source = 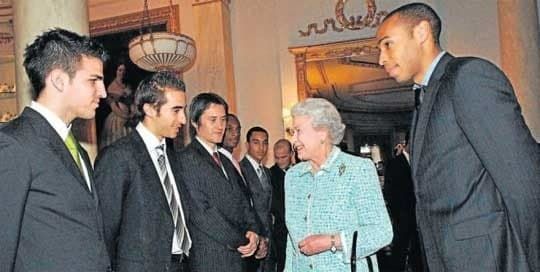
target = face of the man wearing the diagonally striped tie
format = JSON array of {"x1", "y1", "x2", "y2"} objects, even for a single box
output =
[{"x1": 144, "y1": 87, "x2": 186, "y2": 140}]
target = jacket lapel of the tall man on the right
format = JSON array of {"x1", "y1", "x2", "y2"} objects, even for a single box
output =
[{"x1": 411, "y1": 53, "x2": 454, "y2": 177}]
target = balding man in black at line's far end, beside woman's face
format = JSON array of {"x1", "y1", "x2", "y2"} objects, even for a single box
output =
[{"x1": 270, "y1": 139, "x2": 294, "y2": 272}]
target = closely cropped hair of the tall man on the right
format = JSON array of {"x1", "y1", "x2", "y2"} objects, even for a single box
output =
[{"x1": 383, "y1": 3, "x2": 442, "y2": 45}]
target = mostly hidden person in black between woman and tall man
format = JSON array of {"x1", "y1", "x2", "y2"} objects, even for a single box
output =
[{"x1": 384, "y1": 139, "x2": 422, "y2": 271}]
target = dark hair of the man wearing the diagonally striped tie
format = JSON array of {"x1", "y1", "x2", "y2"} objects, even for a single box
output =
[{"x1": 132, "y1": 71, "x2": 186, "y2": 124}]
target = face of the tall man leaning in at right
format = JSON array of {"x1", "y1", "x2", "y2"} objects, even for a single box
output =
[{"x1": 377, "y1": 15, "x2": 423, "y2": 83}]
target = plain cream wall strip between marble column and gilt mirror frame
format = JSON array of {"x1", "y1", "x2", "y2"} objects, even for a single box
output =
[{"x1": 231, "y1": 0, "x2": 283, "y2": 163}]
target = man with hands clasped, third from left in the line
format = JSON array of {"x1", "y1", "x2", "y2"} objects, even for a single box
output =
[{"x1": 179, "y1": 93, "x2": 260, "y2": 272}]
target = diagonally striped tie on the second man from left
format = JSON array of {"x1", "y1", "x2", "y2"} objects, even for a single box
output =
[{"x1": 156, "y1": 145, "x2": 191, "y2": 255}]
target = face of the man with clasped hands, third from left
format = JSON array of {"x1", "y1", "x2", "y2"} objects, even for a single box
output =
[{"x1": 192, "y1": 103, "x2": 227, "y2": 148}]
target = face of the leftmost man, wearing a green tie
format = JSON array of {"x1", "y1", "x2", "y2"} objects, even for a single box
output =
[{"x1": 61, "y1": 55, "x2": 107, "y2": 122}]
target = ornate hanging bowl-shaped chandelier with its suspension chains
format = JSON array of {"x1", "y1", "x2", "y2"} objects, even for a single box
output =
[{"x1": 129, "y1": 0, "x2": 197, "y2": 72}]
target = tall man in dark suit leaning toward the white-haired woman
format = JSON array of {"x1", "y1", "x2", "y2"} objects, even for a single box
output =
[{"x1": 377, "y1": 3, "x2": 540, "y2": 271}]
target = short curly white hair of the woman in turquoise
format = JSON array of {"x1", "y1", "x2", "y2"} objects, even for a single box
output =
[{"x1": 291, "y1": 98, "x2": 345, "y2": 145}]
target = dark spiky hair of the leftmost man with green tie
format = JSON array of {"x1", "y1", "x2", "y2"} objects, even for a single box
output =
[{"x1": 23, "y1": 28, "x2": 108, "y2": 99}]
